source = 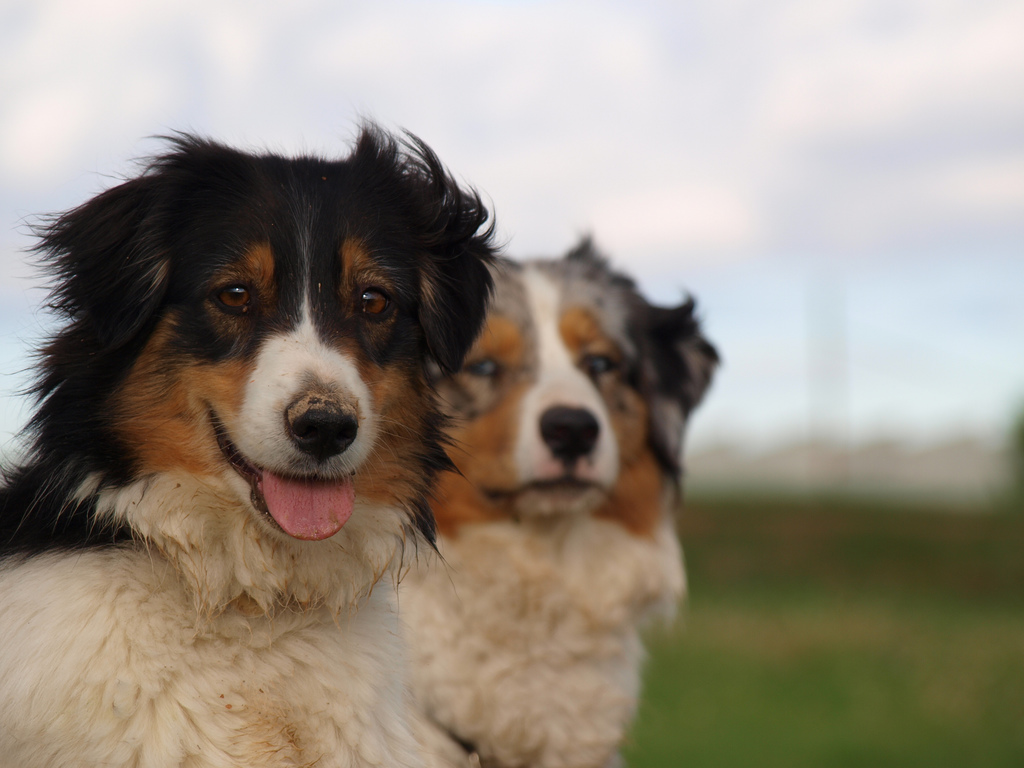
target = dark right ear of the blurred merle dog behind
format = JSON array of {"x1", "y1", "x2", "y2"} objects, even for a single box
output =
[{"x1": 634, "y1": 297, "x2": 719, "y2": 472}]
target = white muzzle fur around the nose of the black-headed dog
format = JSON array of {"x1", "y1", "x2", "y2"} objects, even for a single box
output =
[{"x1": 230, "y1": 308, "x2": 378, "y2": 475}]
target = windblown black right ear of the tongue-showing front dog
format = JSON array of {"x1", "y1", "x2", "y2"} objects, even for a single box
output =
[{"x1": 393, "y1": 134, "x2": 497, "y2": 374}]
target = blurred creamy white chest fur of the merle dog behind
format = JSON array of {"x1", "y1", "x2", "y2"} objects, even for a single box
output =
[{"x1": 402, "y1": 517, "x2": 685, "y2": 768}]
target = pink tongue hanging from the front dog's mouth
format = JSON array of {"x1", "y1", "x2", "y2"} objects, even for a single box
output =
[{"x1": 260, "y1": 472, "x2": 355, "y2": 542}]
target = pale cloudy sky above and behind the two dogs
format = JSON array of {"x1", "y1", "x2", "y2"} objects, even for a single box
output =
[{"x1": 0, "y1": 0, "x2": 1024, "y2": 450}]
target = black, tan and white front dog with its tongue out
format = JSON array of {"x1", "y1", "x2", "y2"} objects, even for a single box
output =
[{"x1": 0, "y1": 127, "x2": 493, "y2": 768}]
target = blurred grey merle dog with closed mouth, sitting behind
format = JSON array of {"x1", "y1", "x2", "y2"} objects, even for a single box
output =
[{"x1": 402, "y1": 241, "x2": 718, "y2": 768}]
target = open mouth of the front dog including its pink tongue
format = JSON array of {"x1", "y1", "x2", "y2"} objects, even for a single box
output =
[{"x1": 210, "y1": 410, "x2": 355, "y2": 542}]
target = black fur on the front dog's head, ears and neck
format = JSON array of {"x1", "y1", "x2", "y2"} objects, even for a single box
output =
[{"x1": 0, "y1": 126, "x2": 494, "y2": 556}]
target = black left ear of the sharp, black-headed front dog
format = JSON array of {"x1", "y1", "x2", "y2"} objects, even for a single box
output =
[{"x1": 36, "y1": 175, "x2": 170, "y2": 348}]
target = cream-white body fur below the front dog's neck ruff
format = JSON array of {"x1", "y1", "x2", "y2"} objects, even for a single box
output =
[{"x1": 0, "y1": 550, "x2": 420, "y2": 768}]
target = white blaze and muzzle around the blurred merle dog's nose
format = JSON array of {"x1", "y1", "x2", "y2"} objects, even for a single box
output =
[{"x1": 515, "y1": 268, "x2": 618, "y2": 488}]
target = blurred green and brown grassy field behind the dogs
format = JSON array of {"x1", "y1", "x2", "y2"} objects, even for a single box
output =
[{"x1": 626, "y1": 500, "x2": 1024, "y2": 768}]
